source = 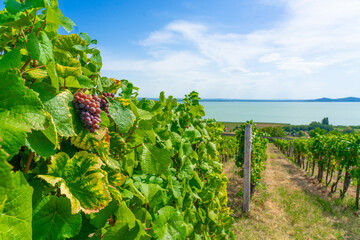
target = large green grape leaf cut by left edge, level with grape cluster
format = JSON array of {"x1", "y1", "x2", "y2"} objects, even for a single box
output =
[{"x1": 0, "y1": 73, "x2": 46, "y2": 156}]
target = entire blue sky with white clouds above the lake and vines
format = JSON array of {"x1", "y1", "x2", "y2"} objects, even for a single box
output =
[{"x1": 2, "y1": 0, "x2": 360, "y2": 99}]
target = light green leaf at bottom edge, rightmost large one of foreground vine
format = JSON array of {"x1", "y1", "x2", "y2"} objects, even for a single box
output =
[{"x1": 152, "y1": 206, "x2": 186, "y2": 240}]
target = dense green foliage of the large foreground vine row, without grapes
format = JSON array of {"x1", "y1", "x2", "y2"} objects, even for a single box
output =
[{"x1": 0, "y1": 0, "x2": 234, "y2": 240}]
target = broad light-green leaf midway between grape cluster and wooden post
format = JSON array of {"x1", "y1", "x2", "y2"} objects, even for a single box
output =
[{"x1": 140, "y1": 144, "x2": 171, "y2": 174}]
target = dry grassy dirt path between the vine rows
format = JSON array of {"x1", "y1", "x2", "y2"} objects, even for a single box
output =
[{"x1": 224, "y1": 144, "x2": 360, "y2": 239}]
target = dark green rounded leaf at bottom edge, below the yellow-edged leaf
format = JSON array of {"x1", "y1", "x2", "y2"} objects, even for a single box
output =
[{"x1": 33, "y1": 196, "x2": 81, "y2": 240}]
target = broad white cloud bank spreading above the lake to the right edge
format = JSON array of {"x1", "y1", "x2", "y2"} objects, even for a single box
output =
[{"x1": 104, "y1": 0, "x2": 360, "y2": 98}]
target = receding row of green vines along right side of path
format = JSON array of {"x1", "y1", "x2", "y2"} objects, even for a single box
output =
[{"x1": 274, "y1": 134, "x2": 360, "y2": 208}]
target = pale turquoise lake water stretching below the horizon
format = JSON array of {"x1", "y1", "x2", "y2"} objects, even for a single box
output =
[{"x1": 201, "y1": 102, "x2": 360, "y2": 126}]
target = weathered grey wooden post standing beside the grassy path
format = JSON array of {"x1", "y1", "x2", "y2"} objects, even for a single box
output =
[{"x1": 242, "y1": 125, "x2": 252, "y2": 212}]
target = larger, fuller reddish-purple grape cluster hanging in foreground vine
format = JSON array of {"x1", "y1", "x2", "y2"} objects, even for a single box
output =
[{"x1": 74, "y1": 92, "x2": 101, "y2": 133}]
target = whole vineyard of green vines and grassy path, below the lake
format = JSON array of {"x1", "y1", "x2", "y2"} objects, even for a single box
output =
[{"x1": 0, "y1": 0, "x2": 360, "y2": 240}]
